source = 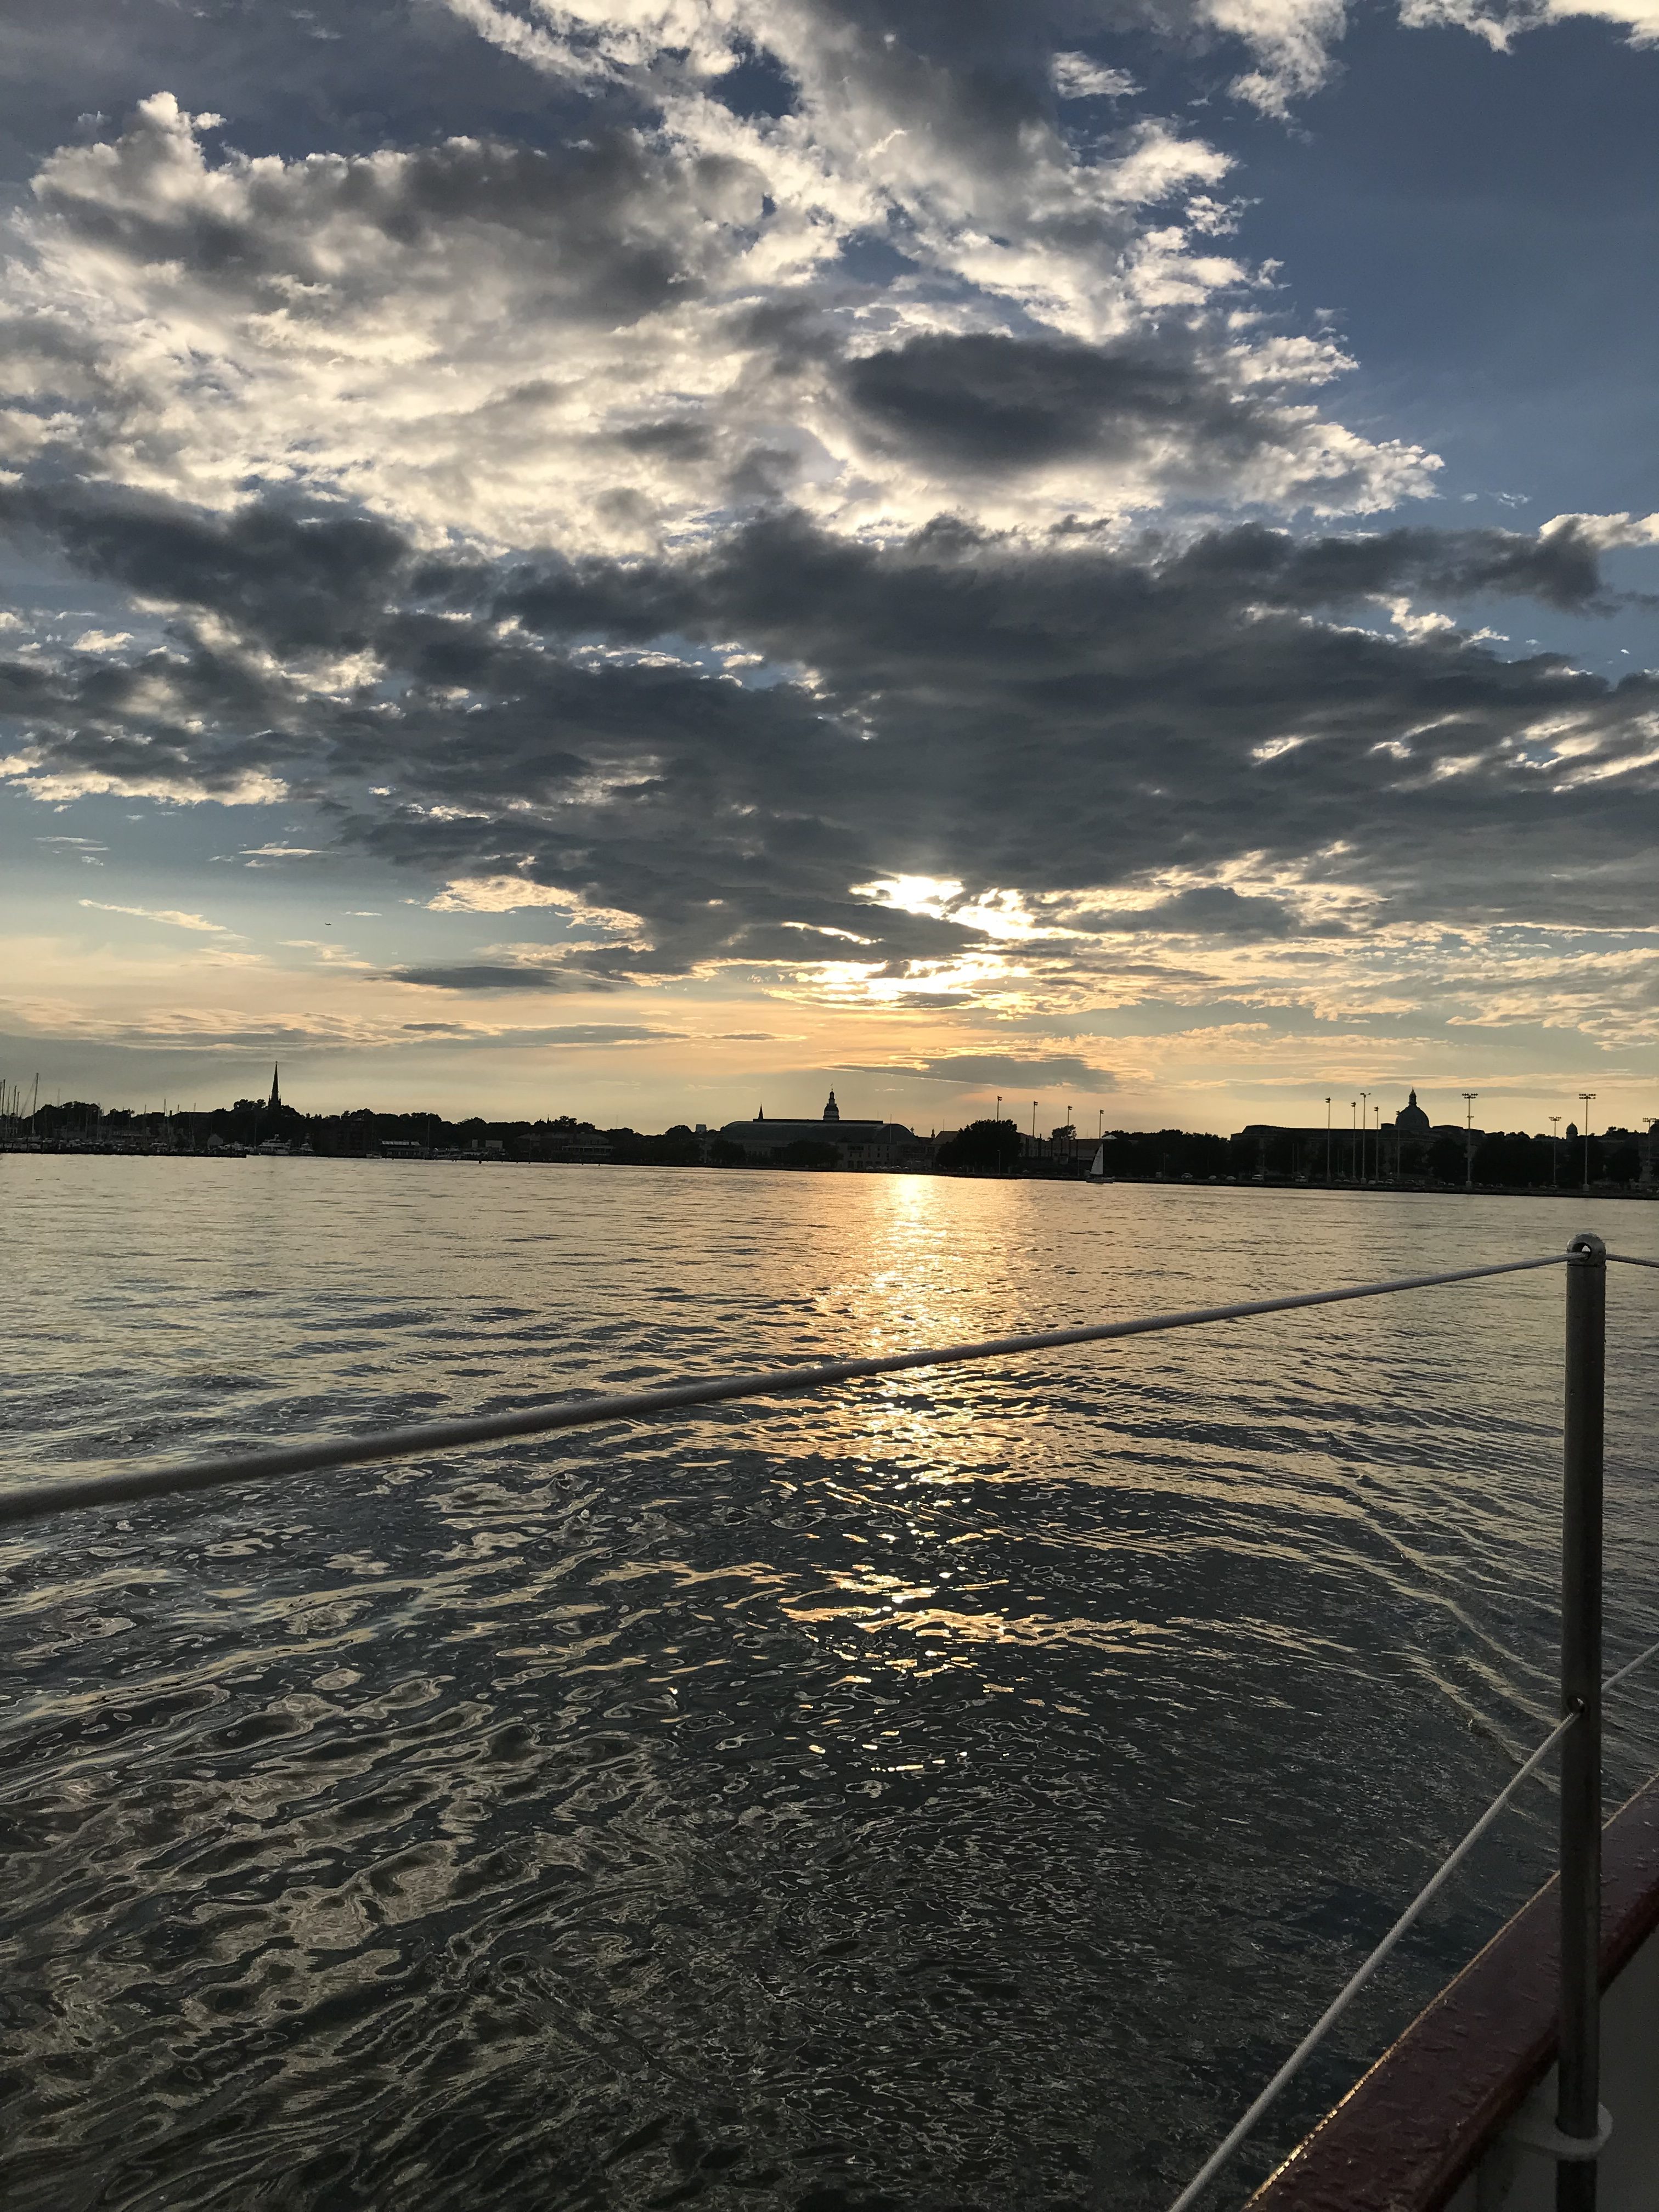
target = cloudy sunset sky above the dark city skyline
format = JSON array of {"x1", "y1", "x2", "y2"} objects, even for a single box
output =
[{"x1": 0, "y1": 0, "x2": 1659, "y2": 1132}]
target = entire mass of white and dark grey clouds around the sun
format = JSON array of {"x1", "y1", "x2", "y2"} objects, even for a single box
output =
[{"x1": 0, "y1": 0, "x2": 1659, "y2": 1084}]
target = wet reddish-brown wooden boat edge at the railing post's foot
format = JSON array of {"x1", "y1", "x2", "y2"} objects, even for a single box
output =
[{"x1": 1248, "y1": 1774, "x2": 1659, "y2": 2212}]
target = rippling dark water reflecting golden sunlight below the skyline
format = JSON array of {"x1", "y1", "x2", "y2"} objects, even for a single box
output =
[{"x1": 0, "y1": 1157, "x2": 1659, "y2": 2212}]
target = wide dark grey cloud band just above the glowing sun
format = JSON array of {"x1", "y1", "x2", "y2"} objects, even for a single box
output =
[{"x1": 0, "y1": 498, "x2": 1659, "y2": 991}]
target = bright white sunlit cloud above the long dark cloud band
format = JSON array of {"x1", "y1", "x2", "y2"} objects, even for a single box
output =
[{"x1": 0, "y1": 45, "x2": 1434, "y2": 550}]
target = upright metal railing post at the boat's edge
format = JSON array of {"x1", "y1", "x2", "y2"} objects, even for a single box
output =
[{"x1": 1555, "y1": 1234, "x2": 1608, "y2": 2212}]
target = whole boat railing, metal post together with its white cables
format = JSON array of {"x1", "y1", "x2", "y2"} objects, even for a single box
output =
[{"x1": 0, "y1": 1232, "x2": 1659, "y2": 2212}]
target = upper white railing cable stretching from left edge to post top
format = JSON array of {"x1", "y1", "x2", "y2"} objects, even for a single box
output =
[{"x1": 0, "y1": 1252, "x2": 1566, "y2": 1526}]
